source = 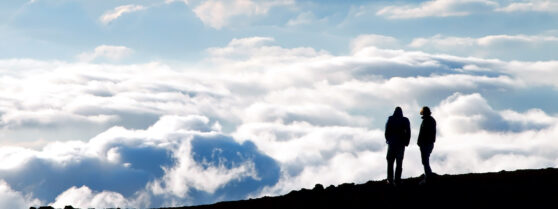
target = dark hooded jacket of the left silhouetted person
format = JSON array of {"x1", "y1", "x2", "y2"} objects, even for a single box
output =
[{"x1": 385, "y1": 108, "x2": 411, "y2": 146}]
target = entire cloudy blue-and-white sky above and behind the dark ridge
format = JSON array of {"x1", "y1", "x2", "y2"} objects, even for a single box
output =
[{"x1": 0, "y1": 0, "x2": 558, "y2": 208}]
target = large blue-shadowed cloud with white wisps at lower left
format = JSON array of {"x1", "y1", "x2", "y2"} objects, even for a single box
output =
[{"x1": 0, "y1": 115, "x2": 279, "y2": 208}]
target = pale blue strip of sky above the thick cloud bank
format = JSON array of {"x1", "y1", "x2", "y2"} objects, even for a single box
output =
[{"x1": 4, "y1": 0, "x2": 558, "y2": 62}]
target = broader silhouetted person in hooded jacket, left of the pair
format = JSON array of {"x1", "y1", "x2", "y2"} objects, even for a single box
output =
[{"x1": 385, "y1": 107, "x2": 411, "y2": 185}]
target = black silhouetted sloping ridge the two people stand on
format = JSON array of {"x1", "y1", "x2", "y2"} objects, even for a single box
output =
[{"x1": 34, "y1": 168, "x2": 558, "y2": 209}]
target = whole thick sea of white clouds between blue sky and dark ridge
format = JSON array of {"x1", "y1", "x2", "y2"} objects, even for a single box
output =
[{"x1": 0, "y1": 34, "x2": 558, "y2": 207}]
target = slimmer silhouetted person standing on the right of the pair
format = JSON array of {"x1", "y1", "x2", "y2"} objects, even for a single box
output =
[{"x1": 417, "y1": 106, "x2": 436, "y2": 183}]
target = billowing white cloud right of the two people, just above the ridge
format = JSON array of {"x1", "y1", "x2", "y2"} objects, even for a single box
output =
[{"x1": 433, "y1": 94, "x2": 558, "y2": 173}]
